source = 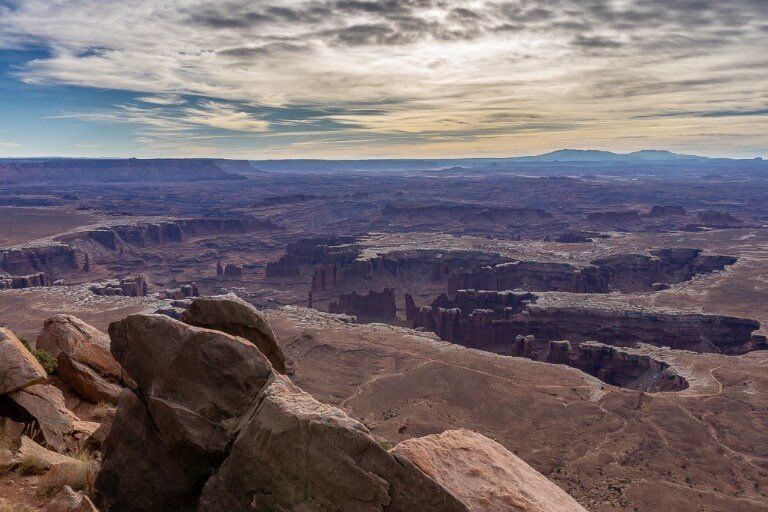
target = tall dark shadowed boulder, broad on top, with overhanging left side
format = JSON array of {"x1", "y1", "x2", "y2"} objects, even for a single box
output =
[{"x1": 96, "y1": 315, "x2": 273, "y2": 512}]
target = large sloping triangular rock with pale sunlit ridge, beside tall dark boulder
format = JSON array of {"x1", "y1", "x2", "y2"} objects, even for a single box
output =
[{"x1": 198, "y1": 376, "x2": 466, "y2": 512}]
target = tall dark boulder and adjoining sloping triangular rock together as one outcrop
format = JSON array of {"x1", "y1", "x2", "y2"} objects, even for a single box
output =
[{"x1": 95, "y1": 315, "x2": 467, "y2": 512}]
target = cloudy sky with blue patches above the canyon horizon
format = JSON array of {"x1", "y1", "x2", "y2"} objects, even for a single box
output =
[{"x1": 0, "y1": 0, "x2": 768, "y2": 159}]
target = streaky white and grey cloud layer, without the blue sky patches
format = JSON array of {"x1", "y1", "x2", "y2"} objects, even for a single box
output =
[{"x1": 0, "y1": 0, "x2": 768, "y2": 156}]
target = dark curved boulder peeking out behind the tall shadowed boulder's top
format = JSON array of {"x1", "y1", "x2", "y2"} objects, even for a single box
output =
[{"x1": 181, "y1": 294, "x2": 285, "y2": 374}]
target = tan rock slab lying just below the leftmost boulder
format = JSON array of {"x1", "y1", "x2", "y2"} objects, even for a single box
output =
[{"x1": 8, "y1": 384, "x2": 80, "y2": 451}]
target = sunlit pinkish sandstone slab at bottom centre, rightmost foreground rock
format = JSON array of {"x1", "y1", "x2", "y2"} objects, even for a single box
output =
[{"x1": 392, "y1": 430, "x2": 586, "y2": 512}]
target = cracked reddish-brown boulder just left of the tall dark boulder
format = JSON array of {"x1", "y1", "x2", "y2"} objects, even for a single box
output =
[{"x1": 37, "y1": 315, "x2": 127, "y2": 403}]
